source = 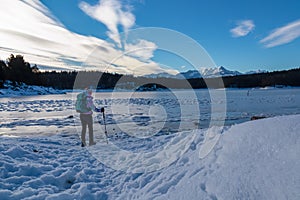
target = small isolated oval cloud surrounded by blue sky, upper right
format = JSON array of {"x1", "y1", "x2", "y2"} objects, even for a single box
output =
[{"x1": 230, "y1": 20, "x2": 255, "y2": 37}]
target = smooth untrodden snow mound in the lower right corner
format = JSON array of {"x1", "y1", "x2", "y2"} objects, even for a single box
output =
[{"x1": 207, "y1": 116, "x2": 300, "y2": 199}]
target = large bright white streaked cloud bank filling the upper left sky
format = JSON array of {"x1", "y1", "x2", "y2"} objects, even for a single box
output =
[{"x1": 0, "y1": 0, "x2": 169, "y2": 75}]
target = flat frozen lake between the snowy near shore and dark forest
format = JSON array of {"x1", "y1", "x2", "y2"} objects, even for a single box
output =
[{"x1": 0, "y1": 88, "x2": 300, "y2": 137}]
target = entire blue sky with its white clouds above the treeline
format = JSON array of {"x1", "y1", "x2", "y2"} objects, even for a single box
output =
[{"x1": 0, "y1": 0, "x2": 300, "y2": 74}]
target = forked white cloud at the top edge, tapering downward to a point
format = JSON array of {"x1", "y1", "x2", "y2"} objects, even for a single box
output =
[{"x1": 79, "y1": 0, "x2": 135, "y2": 47}]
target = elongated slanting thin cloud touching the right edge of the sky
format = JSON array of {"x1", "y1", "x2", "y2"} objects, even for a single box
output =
[{"x1": 260, "y1": 20, "x2": 300, "y2": 48}]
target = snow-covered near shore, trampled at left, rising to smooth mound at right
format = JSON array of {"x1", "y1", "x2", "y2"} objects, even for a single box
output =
[{"x1": 0, "y1": 115, "x2": 300, "y2": 200}]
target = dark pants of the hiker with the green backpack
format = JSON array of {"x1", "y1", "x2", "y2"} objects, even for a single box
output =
[{"x1": 80, "y1": 114, "x2": 94, "y2": 146}]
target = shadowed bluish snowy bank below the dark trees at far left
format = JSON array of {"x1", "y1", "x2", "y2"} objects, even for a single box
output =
[{"x1": 0, "y1": 81, "x2": 65, "y2": 97}]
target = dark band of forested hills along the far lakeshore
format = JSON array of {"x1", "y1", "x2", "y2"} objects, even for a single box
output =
[{"x1": 0, "y1": 55, "x2": 300, "y2": 89}]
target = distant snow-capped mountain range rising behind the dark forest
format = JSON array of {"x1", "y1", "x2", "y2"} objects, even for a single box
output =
[{"x1": 144, "y1": 66, "x2": 267, "y2": 79}]
